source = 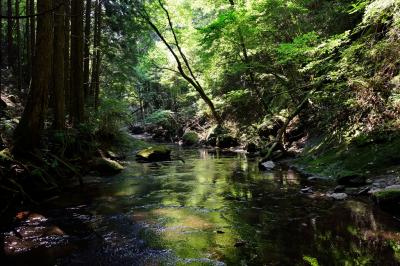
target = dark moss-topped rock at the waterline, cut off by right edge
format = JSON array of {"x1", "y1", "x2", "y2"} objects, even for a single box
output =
[{"x1": 372, "y1": 188, "x2": 400, "y2": 213}]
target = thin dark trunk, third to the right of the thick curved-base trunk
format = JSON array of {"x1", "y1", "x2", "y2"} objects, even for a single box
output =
[{"x1": 83, "y1": 0, "x2": 92, "y2": 101}]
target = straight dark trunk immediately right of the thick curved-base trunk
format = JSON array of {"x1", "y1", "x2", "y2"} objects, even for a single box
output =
[{"x1": 53, "y1": 0, "x2": 65, "y2": 130}]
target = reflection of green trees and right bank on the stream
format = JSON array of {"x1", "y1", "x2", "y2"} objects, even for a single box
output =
[{"x1": 52, "y1": 150, "x2": 395, "y2": 265}]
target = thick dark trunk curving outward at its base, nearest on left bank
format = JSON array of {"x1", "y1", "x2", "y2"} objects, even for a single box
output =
[{"x1": 14, "y1": 0, "x2": 53, "y2": 153}]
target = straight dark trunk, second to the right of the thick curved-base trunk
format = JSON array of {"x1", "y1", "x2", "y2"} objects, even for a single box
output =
[{"x1": 71, "y1": 0, "x2": 84, "y2": 126}]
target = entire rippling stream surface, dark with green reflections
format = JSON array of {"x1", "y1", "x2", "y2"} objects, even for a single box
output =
[{"x1": 0, "y1": 147, "x2": 400, "y2": 266}]
